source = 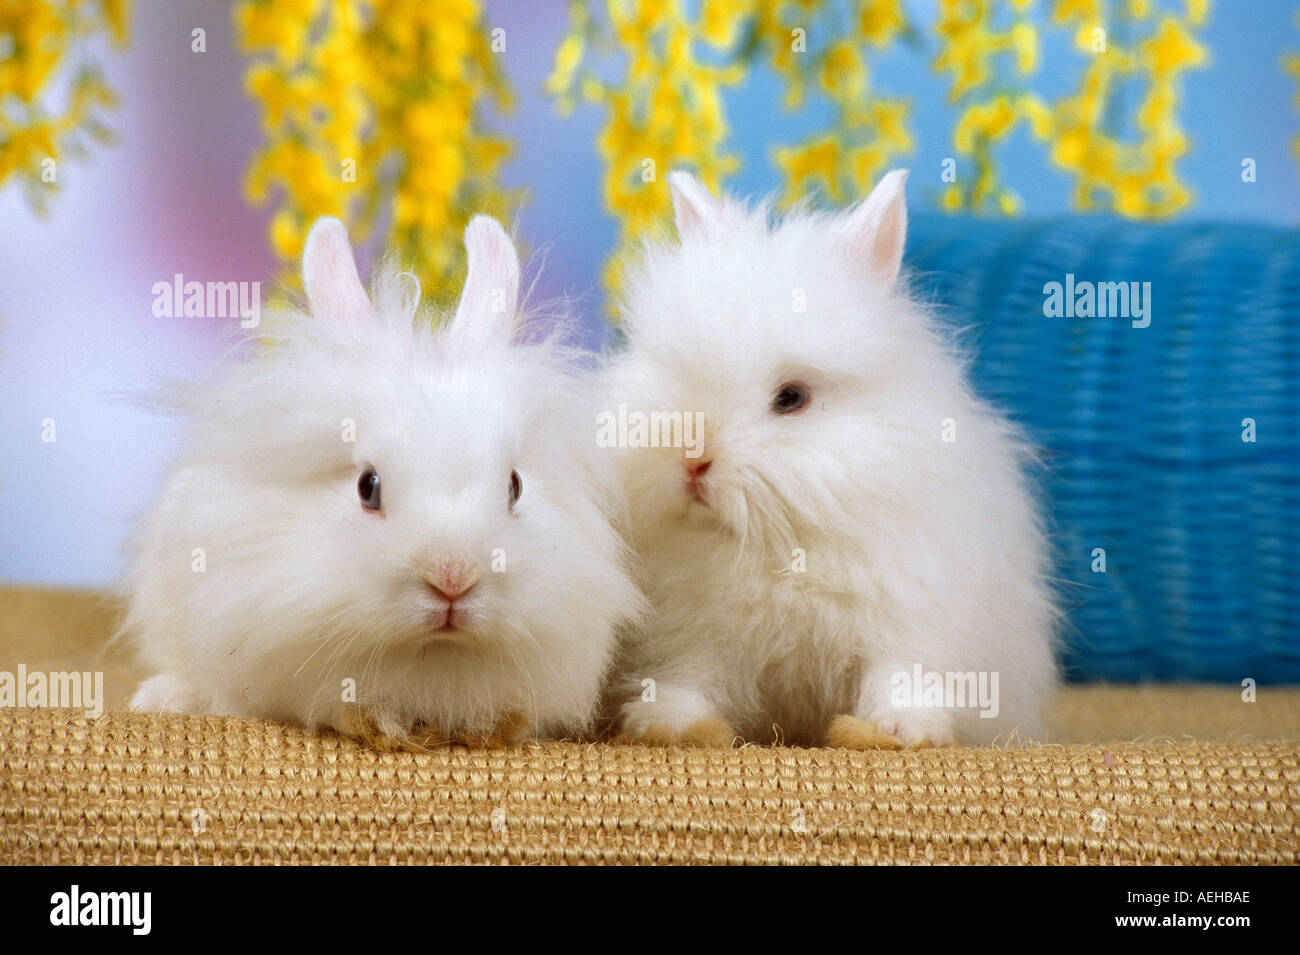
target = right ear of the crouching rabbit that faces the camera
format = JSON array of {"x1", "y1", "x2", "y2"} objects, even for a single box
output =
[{"x1": 447, "y1": 216, "x2": 519, "y2": 350}]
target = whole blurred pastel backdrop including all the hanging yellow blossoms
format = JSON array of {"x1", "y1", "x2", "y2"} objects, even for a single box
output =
[{"x1": 0, "y1": 0, "x2": 1300, "y2": 586}]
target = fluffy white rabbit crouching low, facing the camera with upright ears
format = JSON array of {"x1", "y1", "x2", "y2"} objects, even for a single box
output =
[{"x1": 124, "y1": 216, "x2": 641, "y2": 746}]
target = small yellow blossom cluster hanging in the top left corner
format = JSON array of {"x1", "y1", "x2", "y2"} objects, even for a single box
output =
[{"x1": 0, "y1": 0, "x2": 129, "y2": 213}]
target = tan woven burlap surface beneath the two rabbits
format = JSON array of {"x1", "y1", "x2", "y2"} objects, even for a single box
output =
[{"x1": 0, "y1": 590, "x2": 1300, "y2": 864}]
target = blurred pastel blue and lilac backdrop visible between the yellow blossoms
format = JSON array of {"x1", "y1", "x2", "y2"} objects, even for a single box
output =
[{"x1": 0, "y1": 0, "x2": 1300, "y2": 585}]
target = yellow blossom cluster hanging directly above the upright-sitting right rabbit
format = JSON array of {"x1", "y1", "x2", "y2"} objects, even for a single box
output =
[{"x1": 546, "y1": 0, "x2": 913, "y2": 306}]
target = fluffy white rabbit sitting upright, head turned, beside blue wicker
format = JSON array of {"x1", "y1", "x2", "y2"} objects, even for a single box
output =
[{"x1": 606, "y1": 172, "x2": 1058, "y2": 747}]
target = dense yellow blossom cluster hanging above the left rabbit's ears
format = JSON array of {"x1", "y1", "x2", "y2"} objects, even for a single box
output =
[{"x1": 234, "y1": 0, "x2": 510, "y2": 302}]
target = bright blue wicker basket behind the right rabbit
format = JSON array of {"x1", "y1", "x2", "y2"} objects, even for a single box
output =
[{"x1": 907, "y1": 217, "x2": 1300, "y2": 683}]
